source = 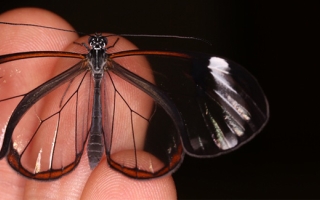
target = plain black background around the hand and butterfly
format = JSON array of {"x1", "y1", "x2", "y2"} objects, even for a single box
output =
[{"x1": 0, "y1": 0, "x2": 320, "y2": 199}]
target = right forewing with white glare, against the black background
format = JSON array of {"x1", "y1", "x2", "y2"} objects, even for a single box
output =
[{"x1": 110, "y1": 51, "x2": 269, "y2": 162}]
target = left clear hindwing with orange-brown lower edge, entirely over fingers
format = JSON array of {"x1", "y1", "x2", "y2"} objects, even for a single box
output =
[{"x1": 1, "y1": 54, "x2": 92, "y2": 179}]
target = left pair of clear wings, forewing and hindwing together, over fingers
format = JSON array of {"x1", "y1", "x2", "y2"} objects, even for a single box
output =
[{"x1": 0, "y1": 53, "x2": 92, "y2": 180}]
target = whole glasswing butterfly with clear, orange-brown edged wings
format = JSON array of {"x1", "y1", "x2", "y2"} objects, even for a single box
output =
[{"x1": 0, "y1": 22, "x2": 269, "y2": 180}]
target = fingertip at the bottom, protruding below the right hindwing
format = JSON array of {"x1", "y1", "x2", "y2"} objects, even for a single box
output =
[{"x1": 81, "y1": 161, "x2": 177, "y2": 200}]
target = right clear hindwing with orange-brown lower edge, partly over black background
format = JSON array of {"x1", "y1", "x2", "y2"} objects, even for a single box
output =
[{"x1": 102, "y1": 57, "x2": 184, "y2": 179}]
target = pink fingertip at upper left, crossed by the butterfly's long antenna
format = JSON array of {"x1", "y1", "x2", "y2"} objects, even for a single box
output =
[{"x1": 0, "y1": 8, "x2": 77, "y2": 54}]
